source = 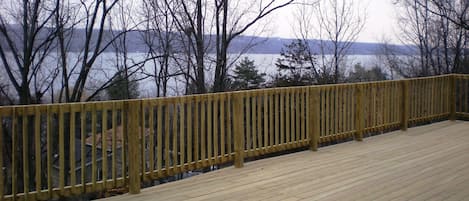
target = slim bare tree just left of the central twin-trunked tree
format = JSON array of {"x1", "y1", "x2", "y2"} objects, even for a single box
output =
[{"x1": 141, "y1": 0, "x2": 183, "y2": 97}]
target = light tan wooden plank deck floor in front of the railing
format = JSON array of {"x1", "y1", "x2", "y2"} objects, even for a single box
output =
[{"x1": 101, "y1": 121, "x2": 469, "y2": 201}]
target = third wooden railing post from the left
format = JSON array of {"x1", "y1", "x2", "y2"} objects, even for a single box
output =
[{"x1": 308, "y1": 87, "x2": 320, "y2": 151}]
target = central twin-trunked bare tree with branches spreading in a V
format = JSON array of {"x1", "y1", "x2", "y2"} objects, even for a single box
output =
[{"x1": 165, "y1": 0, "x2": 294, "y2": 93}]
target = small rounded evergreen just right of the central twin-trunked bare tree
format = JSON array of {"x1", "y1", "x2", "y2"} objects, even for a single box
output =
[{"x1": 232, "y1": 57, "x2": 265, "y2": 90}]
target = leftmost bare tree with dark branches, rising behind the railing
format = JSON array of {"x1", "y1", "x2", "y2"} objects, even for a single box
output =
[{"x1": 0, "y1": 0, "x2": 57, "y2": 104}]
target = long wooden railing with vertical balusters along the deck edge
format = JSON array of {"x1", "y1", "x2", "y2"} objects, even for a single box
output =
[{"x1": 0, "y1": 75, "x2": 469, "y2": 200}]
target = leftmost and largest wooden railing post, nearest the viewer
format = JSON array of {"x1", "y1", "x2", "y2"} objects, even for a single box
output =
[{"x1": 124, "y1": 101, "x2": 140, "y2": 194}]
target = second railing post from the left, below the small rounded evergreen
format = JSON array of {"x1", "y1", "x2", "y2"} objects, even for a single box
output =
[{"x1": 231, "y1": 93, "x2": 244, "y2": 168}]
